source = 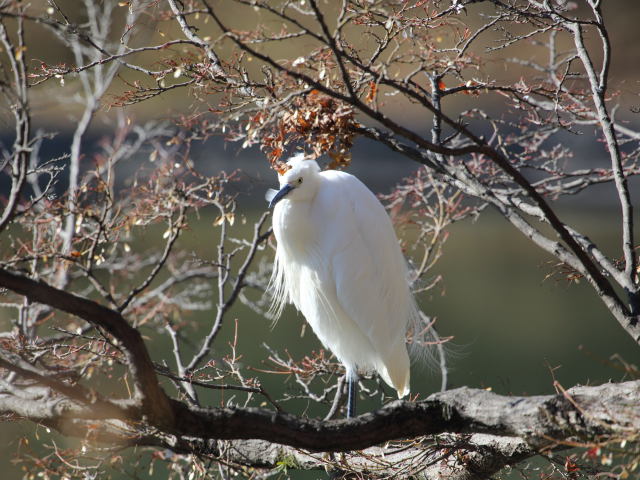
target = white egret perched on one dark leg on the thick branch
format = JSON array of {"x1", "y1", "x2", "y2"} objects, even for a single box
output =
[{"x1": 267, "y1": 155, "x2": 419, "y2": 416}]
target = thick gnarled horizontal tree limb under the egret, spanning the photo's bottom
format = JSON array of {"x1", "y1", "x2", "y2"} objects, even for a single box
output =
[{"x1": 0, "y1": 380, "x2": 640, "y2": 478}]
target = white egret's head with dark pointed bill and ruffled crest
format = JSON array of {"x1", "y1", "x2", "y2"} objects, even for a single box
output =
[{"x1": 269, "y1": 154, "x2": 320, "y2": 207}]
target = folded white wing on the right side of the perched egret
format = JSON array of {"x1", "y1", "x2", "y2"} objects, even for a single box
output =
[{"x1": 323, "y1": 171, "x2": 414, "y2": 349}]
